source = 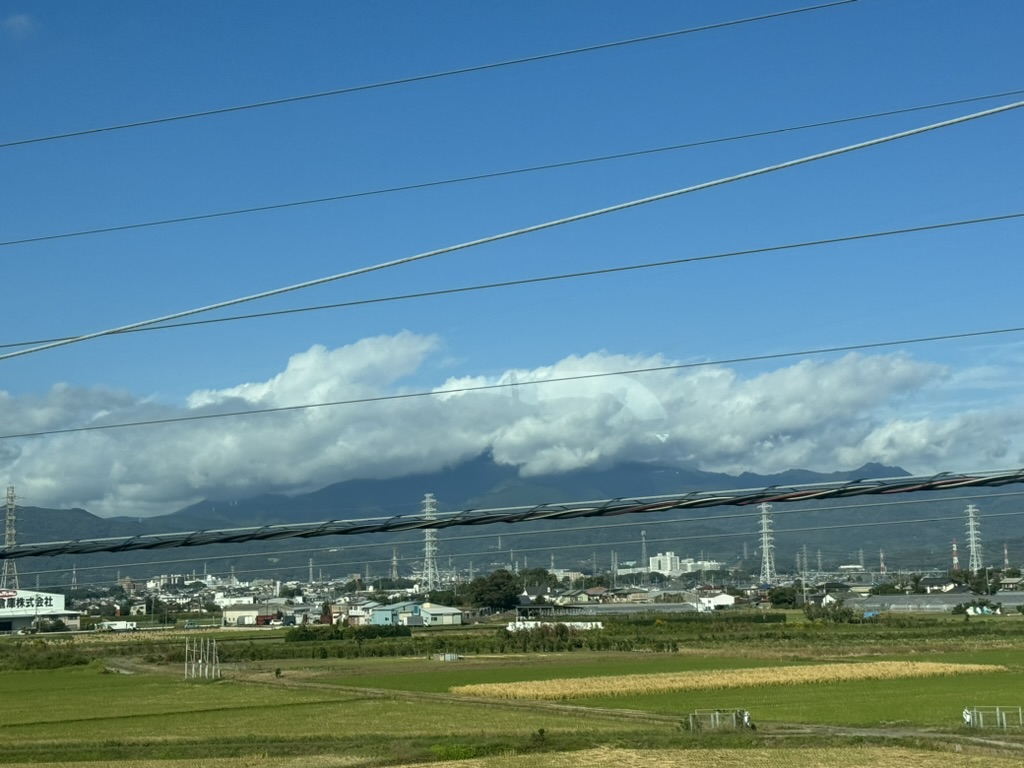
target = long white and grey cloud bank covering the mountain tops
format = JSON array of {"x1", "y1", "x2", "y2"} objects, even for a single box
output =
[{"x1": 0, "y1": 332, "x2": 1024, "y2": 516}]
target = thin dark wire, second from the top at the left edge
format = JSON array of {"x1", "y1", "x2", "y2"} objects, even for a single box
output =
[{"x1": 0, "y1": 89, "x2": 1024, "y2": 248}]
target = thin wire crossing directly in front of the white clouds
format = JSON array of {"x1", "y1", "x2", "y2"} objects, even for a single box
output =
[{"x1": 6, "y1": 326, "x2": 1024, "y2": 440}]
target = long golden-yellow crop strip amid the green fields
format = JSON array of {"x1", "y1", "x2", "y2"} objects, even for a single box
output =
[{"x1": 449, "y1": 662, "x2": 1007, "y2": 699}]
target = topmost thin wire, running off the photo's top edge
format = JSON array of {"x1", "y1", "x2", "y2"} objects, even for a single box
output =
[{"x1": 0, "y1": 0, "x2": 857, "y2": 150}]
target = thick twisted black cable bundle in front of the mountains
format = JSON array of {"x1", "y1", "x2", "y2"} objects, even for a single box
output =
[{"x1": 0, "y1": 469, "x2": 1024, "y2": 560}]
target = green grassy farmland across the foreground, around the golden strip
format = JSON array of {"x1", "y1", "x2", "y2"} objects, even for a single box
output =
[{"x1": 0, "y1": 628, "x2": 1024, "y2": 768}]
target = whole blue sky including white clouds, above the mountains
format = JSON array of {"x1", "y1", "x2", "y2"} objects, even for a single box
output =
[{"x1": 0, "y1": 0, "x2": 1024, "y2": 515}]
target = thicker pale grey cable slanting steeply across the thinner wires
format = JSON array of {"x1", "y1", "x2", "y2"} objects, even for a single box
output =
[{"x1": 0, "y1": 101, "x2": 1024, "y2": 360}]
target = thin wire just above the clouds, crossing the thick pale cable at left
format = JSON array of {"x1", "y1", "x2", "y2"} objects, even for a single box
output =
[{"x1": 0, "y1": 212, "x2": 1024, "y2": 349}]
